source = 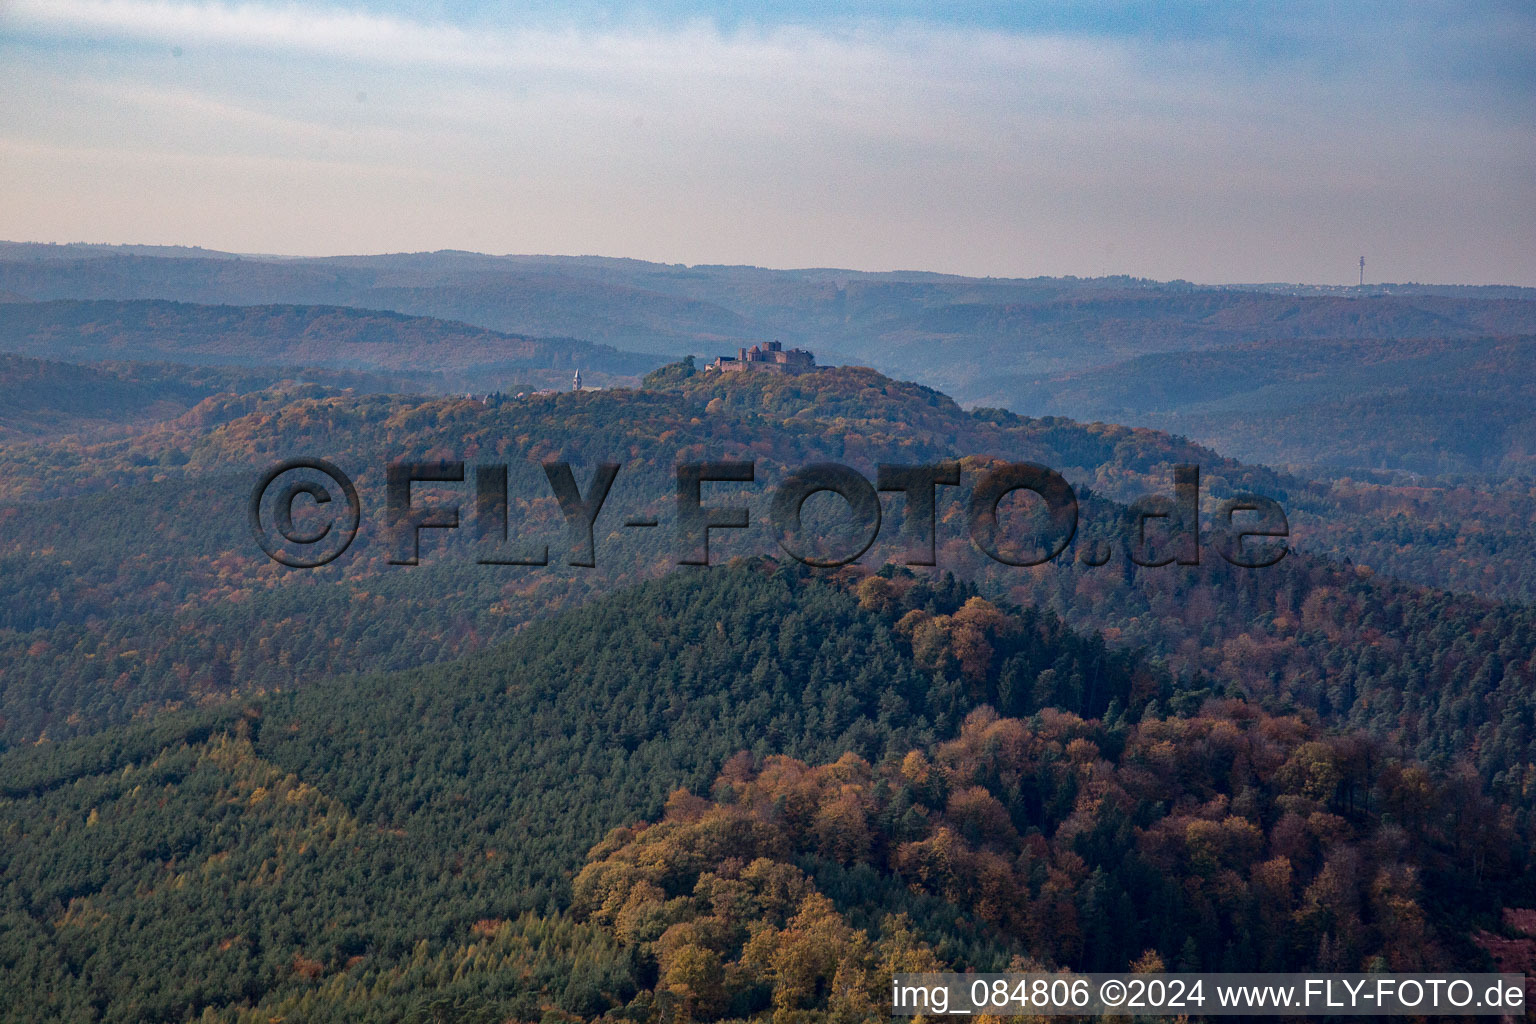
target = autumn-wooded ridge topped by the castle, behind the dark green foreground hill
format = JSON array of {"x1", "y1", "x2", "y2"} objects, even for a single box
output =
[{"x1": 9, "y1": 365, "x2": 1536, "y2": 806}]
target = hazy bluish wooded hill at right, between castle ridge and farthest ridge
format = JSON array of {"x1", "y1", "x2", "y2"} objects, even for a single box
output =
[{"x1": 989, "y1": 335, "x2": 1536, "y2": 477}]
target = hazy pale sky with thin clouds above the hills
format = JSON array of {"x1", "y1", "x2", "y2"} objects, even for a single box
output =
[{"x1": 0, "y1": 0, "x2": 1536, "y2": 286}]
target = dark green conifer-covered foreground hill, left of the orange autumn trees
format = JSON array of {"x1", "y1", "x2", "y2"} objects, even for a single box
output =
[{"x1": 0, "y1": 565, "x2": 1172, "y2": 1021}]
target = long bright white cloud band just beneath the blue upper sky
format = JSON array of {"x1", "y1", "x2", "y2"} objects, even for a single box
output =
[{"x1": 3, "y1": 0, "x2": 1142, "y2": 97}]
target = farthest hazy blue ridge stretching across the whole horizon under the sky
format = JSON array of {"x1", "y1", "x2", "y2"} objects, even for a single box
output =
[{"x1": 0, "y1": 246, "x2": 1536, "y2": 382}]
